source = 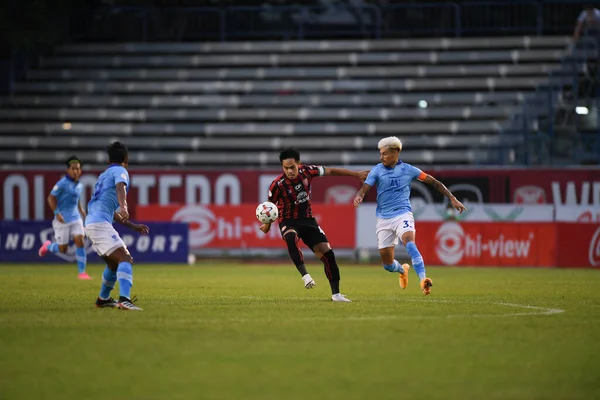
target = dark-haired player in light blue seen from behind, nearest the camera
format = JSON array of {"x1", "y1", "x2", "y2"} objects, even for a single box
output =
[{"x1": 85, "y1": 142, "x2": 150, "y2": 311}]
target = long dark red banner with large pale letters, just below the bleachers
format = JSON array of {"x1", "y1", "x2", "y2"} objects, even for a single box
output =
[{"x1": 0, "y1": 168, "x2": 600, "y2": 220}]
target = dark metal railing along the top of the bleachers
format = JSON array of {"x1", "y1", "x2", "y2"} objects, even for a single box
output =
[{"x1": 70, "y1": 0, "x2": 600, "y2": 42}]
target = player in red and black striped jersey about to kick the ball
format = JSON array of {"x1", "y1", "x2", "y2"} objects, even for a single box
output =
[{"x1": 260, "y1": 148, "x2": 369, "y2": 302}]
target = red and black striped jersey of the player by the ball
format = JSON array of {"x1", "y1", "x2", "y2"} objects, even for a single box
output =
[{"x1": 269, "y1": 164, "x2": 325, "y2": 222}]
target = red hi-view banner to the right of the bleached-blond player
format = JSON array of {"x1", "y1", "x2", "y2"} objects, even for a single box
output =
[{"x1": 417, "y1": 222, "x2": 556, "y2": 267}]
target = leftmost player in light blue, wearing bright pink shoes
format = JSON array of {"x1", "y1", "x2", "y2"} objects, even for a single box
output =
[{"x1": 38, "y1": 156, "x2": 92, "y2": 280}]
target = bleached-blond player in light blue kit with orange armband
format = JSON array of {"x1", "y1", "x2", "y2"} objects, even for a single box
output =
[{"x1": 354, "y1": 136, "x2": 466, "y2": 296}]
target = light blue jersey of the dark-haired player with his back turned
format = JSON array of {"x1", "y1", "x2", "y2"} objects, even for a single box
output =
[{"x1": 85, "y1": 164, "x2": 129, "y2": 226}]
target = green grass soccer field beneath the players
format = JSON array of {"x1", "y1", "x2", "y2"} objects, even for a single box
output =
[{"x1": 0, "y1": 263, "x2": 600, "y2": 400}]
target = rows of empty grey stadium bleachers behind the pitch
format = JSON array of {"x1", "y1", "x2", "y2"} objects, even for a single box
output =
[{"x1": 0, "y1": 36, "x2": 572, "y2": 166}]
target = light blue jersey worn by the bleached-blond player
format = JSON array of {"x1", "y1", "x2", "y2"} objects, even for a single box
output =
[{"x1": 365, "y1": 161, "x2": 425, "y2": 219}]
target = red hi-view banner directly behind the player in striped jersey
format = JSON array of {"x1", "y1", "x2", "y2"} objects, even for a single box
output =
[{"x1": 137, "y1": 204, "x2": 356, "y2": 250}]
